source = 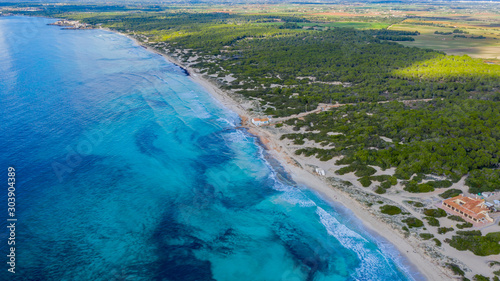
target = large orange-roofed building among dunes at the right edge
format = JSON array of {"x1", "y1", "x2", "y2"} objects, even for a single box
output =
[{"x1": 443, "y1": 194, "x2": 493, "y2": 223}]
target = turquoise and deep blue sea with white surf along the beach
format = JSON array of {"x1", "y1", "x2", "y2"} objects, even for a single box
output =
[{"x1": 0, "y1": 17, "x2": 422, "y2": 281}]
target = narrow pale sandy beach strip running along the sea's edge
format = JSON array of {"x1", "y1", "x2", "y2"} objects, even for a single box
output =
[{"x1": 111, "y1": 28, "x2": 456, "y2": 280}]
